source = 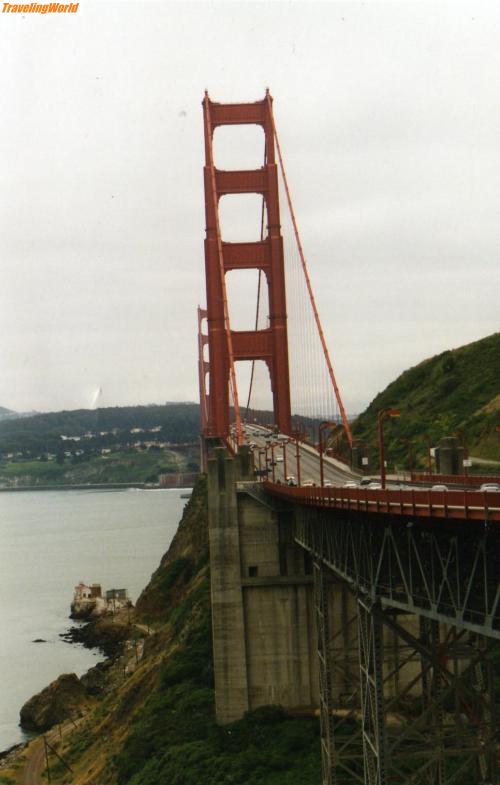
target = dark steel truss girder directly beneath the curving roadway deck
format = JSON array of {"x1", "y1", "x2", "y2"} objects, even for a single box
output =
[{"x1": 294, "y1": 507, "x2": 500, "y2": 640}]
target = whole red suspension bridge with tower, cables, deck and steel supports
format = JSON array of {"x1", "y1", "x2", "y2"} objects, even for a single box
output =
[{"x1": 198, "y1": 91, "x2": 500, "y2": 785}]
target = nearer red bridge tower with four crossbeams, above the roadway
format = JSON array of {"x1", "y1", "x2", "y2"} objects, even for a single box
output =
[{"x1": 200, "y1": 91, "x2": 291, "y2": 439}]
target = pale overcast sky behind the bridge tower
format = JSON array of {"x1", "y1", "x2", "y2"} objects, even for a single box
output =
[{"x1": 0, "y1": 0, "x2": 500, "y2": 412}]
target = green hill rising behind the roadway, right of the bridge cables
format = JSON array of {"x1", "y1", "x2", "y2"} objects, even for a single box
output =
[{"x1": 352, "y1": 333, "x2": 500, "y2": 467}]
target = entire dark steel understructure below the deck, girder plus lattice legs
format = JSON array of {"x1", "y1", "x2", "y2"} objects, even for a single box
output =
[{"x1": 294, "y1": 508, "x2": 500, "y2": 785}]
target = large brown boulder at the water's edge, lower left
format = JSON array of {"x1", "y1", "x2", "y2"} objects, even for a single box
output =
[{"x1": 21, "y1": 673, "x2": 87, "y2": 731}]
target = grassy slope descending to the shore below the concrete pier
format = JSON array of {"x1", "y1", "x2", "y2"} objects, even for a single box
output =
[{"x1": 36, "y1": 479, "x2": 320, "y2": 785}]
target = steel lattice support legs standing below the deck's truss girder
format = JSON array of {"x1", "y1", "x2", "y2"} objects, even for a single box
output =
[{"x1": 324, "y1": 596, "x2": 500, "y2": 785}]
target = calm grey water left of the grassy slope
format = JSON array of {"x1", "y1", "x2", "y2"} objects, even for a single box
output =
[{"x1": 0, "y1": 489, "x2": 186, "y2": 750}]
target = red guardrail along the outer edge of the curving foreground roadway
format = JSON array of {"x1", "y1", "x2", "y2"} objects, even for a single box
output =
[{"x1": 264, "y1": 482, "x2": 500, "y2": 522}]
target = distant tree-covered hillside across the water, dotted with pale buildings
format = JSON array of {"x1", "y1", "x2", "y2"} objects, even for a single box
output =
[{"x1": 0, "y1": 404, "x2": 199, "y2": 487}]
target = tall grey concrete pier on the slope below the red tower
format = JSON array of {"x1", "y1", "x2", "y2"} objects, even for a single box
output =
[{"x1": 208, "y1": 448, "x2": 319, "y2": 723}]
